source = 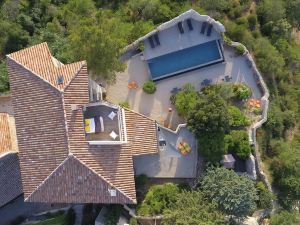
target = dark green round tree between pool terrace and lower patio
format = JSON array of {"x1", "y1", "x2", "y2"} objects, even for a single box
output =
[{"x1": 188, "y1": 94, "x2": 229, "y2": 138}]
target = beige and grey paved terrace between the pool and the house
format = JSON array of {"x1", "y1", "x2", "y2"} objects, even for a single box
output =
[{"x1": 107, "y1": 47, "x2": 262, "y2": 130}]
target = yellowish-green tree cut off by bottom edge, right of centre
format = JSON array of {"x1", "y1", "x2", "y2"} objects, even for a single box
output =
[{"x1": 163, "y1": 191, "x2": 228, "y2": 225}]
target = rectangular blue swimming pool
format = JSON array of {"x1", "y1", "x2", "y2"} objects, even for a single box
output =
[{"x1": 147, "y1": 40, "x2": 223, "y2": 80}]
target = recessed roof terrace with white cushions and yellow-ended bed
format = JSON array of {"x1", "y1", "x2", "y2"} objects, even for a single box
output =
[{"x1": 84, "y1": 102, "x2": 124, "y2": 142}]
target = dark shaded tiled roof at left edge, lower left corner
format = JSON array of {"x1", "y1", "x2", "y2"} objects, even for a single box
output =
[{"x1": 0, "y1": 152, "x2": 22, "y2": 207}]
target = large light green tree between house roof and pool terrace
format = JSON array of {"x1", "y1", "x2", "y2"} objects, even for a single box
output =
[{"x1": 69, "y1": 11, "x2": 125, "y2": 82}]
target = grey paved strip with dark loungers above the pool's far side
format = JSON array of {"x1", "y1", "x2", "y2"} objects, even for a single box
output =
[{"x1": 143, "y1": 19, "x2": 220, "y2": 60}]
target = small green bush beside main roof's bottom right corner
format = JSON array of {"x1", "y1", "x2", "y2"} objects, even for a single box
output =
[{"x1": 137, "y1": 183, "x2": 179, "y2": 215}]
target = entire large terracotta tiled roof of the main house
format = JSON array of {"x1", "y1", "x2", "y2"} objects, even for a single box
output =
[{"x1": 7, "y1": 44, "x2": 157, "y2": 203}]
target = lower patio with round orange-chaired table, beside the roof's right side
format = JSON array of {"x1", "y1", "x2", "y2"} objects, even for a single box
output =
[{"x1": 133, "y1": 127, "x2": 198, "y2": 178}]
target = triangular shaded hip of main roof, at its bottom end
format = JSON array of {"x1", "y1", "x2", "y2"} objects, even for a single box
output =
[{"x1": 28, "y1": 155, "x2": 132, "y2": 204}]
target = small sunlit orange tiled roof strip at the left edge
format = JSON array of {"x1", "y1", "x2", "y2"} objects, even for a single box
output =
[{"x1": 0, "y1": 113, "x2": 12, "y2": 155}]
